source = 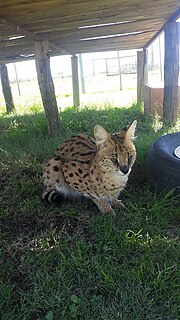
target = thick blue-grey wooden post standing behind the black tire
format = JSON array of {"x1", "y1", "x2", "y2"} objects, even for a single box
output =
[{"x1": 163, "y1": 22, "x2": 180, "y2": 123}]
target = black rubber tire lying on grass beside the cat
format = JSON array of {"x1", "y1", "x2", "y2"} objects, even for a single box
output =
[{"x1": 146, "y1": 132, "x2": 180, "y2": 195}]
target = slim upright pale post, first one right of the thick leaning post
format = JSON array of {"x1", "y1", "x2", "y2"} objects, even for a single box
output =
[{"x1": 71, "y1": 55, "x2": 80, "y2": 107}]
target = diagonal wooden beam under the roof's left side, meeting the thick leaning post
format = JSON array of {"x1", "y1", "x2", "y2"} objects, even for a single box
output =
[{"x1": 0, "y1": 18, "x2": 74, "y2": 54}]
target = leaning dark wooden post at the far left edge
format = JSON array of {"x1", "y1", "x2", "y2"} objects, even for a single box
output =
[{"x1": 0, "y1": 64, "x2": 15, "y2": 113}]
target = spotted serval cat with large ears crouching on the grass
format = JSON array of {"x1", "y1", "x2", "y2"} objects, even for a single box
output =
[{"x1": 42, "y1": 120, "x2": 137, "y2": 214}]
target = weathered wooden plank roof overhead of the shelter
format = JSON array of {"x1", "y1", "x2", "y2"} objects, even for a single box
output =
[{"x1": 0, "y1": 0, "x2": 180, "y2": 63}]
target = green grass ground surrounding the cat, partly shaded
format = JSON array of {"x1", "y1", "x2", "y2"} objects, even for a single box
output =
[{"x1": 0, "y1": 105, "x2": 180, "y2": 320}]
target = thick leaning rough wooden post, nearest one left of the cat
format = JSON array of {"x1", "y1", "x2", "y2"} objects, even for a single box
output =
[{"x1": 35, "y1": 41, "x2": 61, "y2": 135}]
